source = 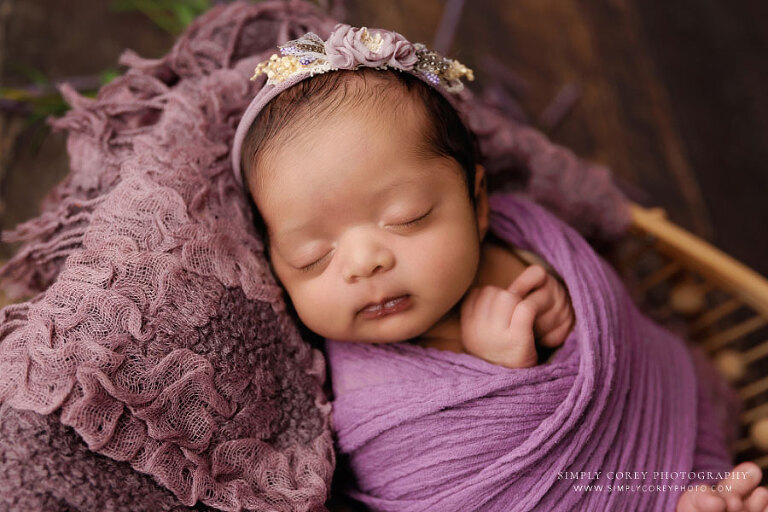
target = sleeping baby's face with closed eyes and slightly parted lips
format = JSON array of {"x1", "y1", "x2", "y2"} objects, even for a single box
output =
[{"x1": 251, "y1": 99, "x2": 484, "y2": 343}]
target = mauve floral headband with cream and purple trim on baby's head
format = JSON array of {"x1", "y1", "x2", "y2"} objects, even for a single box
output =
[{"x1": 232, "y1": 24, "x2": 474, "y2": 185}]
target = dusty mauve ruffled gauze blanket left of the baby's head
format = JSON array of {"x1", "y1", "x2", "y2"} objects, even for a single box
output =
[{"x1": 0, "y1": 2, "x2": 335, "y2": 512}]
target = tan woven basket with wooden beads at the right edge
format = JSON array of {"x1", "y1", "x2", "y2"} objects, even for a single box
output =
[{"x1": 610, "y1": 204, "x2": 768, "y2": 481}]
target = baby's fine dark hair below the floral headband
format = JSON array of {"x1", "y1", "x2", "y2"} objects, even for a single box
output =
[{"x1": 240, "y1": 68, "x2": 479, "y2": 246}]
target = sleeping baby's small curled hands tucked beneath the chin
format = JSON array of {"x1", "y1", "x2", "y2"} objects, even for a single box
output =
[{"x1": 461, "y1": 265, "x2": 575, "y2": 368}]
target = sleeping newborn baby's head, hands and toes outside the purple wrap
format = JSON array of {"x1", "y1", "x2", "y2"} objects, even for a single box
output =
[{"x1": 231, "y1": 25, "x2": 768, "y2": 511}]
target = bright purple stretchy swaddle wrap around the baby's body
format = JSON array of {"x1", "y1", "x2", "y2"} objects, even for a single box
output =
[{"x1": 326, "y1": 194, "x2": 732, "y2": 512}]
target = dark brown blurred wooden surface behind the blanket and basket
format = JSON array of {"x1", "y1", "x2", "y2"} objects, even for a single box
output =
[{"x1": 0, "y1": 0, "x2": 768, "y2": 275}]
